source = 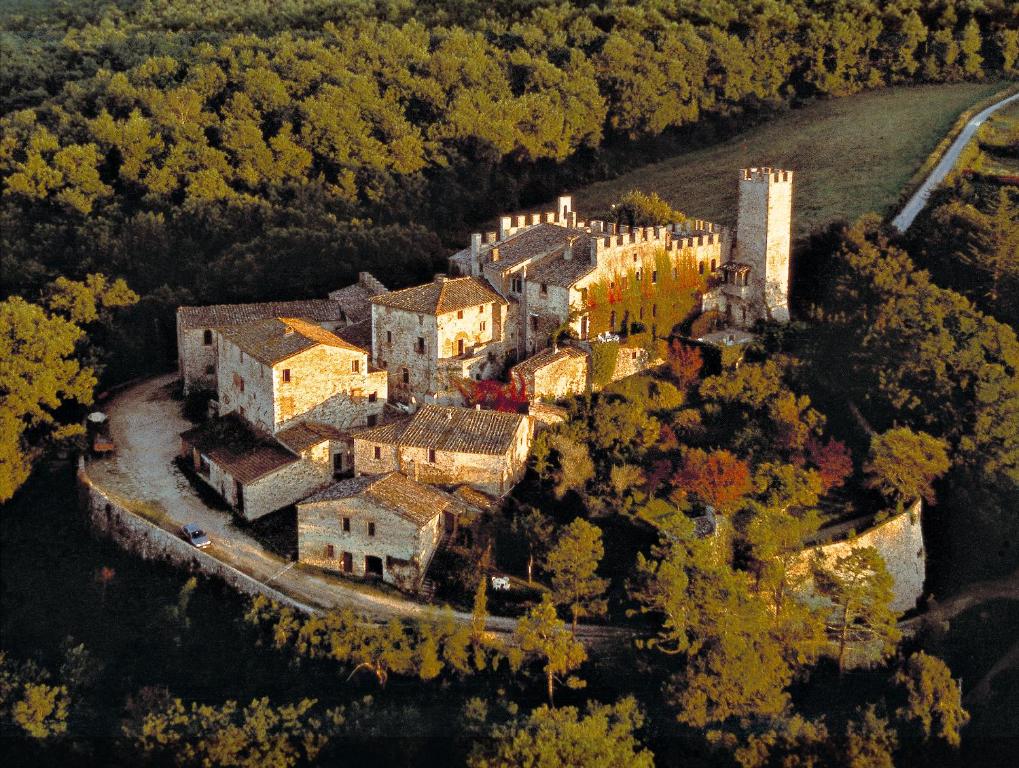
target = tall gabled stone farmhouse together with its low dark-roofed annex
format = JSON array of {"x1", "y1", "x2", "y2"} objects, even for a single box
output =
[{"x1": 181, "y1": 318, "x2": 387, "y2": 519}]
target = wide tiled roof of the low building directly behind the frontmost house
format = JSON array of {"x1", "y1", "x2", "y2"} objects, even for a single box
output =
[{"x1": 352, "y1": 404, "x2": 526, "y2": 456}]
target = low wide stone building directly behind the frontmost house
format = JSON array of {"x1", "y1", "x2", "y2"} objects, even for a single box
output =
[{"x1": 353, "y1": 404, "x2": 533, "y2": 496}]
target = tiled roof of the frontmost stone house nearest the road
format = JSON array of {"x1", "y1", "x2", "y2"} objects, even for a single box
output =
[{"x1": 301, "y1": 472, "x2": 463, "y2": 528}]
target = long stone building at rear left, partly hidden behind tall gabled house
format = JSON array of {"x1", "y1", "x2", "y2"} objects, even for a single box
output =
[{"x1": 176, "y1": 272, "x2": 386, "y2": 394}]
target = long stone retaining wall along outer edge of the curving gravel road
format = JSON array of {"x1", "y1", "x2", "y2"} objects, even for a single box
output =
[{"x1": 77, "y1": 463, "x2": 316, "y2": 613}]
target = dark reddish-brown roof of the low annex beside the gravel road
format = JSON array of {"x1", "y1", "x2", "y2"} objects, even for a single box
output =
[{"x1": 180, "y1": 413, "x2": 300, "y2": 485}]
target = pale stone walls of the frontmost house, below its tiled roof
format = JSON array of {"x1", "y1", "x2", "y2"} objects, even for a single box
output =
[{"x1": 298, "y1": 496, "x2": 442, "y2": 590}]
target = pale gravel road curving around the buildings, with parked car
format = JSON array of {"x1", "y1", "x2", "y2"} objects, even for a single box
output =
[{"x1": 88, "y1": 375, "x2": 630, "y2": 645}]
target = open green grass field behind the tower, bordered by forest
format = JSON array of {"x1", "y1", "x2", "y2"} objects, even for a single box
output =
[{"x1": 571, "y1": 83, "x2": 1003, "y2": 234}]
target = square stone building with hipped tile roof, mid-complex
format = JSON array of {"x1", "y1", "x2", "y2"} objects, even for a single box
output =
[{"x1": 371, "y1": 275, "x2": 507, "y2": 402}]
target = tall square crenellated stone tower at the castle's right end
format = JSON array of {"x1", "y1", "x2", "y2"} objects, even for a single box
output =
[{"x1": 735, "y1": 168, "x2": 793, "y2": 323}]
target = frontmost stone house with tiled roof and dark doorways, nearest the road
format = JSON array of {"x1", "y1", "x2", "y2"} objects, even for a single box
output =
[{"x1": 298, "y1": 472, "x2": 466, "y2": 591}]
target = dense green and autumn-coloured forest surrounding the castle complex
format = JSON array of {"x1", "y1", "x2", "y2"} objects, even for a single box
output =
[{"x1": 0, "y1": 0, "x2": 1019, "y2": 768}]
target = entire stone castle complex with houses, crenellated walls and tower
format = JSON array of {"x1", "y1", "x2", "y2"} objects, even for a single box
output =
[{"x1": 177, "y1": 168, "x2": 793, "y2": 585}]
